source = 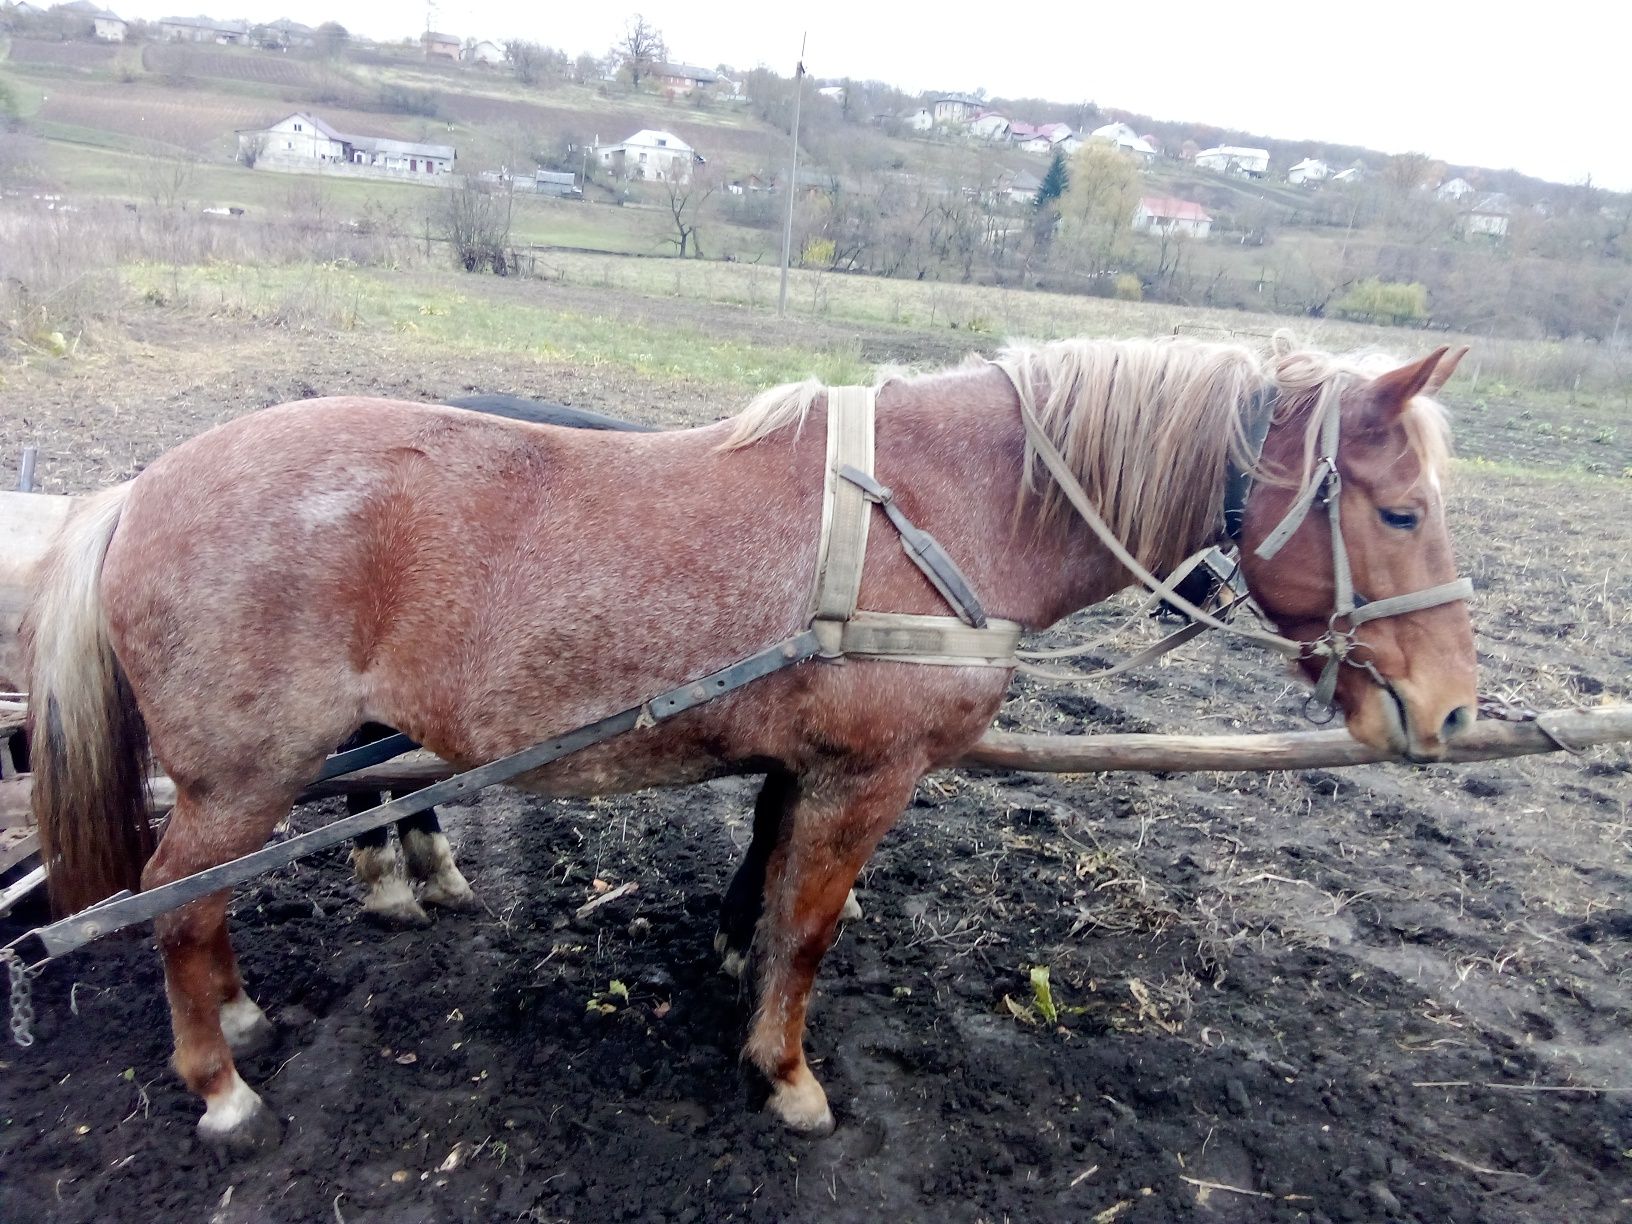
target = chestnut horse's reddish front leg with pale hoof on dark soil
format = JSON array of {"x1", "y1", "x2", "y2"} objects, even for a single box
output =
[{"x1": 743, "y1": 769, "x2": 919, "y2": 1134}]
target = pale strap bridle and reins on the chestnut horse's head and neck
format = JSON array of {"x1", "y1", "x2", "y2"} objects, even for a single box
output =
[{"x1": 994, "y1": 361, "x2": 1474, "y2": 721}]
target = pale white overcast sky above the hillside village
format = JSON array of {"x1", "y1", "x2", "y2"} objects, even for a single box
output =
[{"x1": 116, "y1": 0, "x2": 1632, "y2": 191}]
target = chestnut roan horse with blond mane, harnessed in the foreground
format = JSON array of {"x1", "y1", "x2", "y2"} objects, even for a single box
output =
[{"x1": 28, "y1": 338, "x2": 1475, "y2": 1151}]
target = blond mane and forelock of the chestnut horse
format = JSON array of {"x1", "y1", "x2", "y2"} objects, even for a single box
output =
[{"x1": 721, "y1": 331, "x2": 1449, "y2": 571}]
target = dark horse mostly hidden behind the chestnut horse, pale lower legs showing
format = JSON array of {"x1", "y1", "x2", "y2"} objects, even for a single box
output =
[{"x1": 339, "y1": 393, "x2": 658, "y2": 927}]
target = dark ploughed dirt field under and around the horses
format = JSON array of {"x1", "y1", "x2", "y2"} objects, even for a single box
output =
[{"x1": 0, "y1": 289, "x2": 1632, "y2": 1224}]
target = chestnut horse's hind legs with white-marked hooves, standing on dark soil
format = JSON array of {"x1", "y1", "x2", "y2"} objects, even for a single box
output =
[{"x1": 142, "y1": 788, "x2": 292, "y2": 1151}]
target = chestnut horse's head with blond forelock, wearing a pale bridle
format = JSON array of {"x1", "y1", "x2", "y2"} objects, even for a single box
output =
[{"x1": 1242, "y1": 348, "x2": 1477, "y2": 761}]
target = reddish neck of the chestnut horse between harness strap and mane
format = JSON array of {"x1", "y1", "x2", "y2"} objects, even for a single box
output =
[{"x1": 876, "y1": 367, "x2": 1206, "y2": 628}]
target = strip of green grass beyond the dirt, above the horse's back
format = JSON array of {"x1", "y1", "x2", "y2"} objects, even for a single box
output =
[{"x1": 124, "y1": 264, "x2": 870, "y2": 390}]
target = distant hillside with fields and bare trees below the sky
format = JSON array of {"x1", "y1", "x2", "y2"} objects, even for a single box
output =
[{"x1": 0, "y1": 26, "x2": 1632, "y2": 352}]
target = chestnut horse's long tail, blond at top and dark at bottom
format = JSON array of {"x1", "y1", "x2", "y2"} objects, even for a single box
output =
[{"x1": 23, "y1": 485, "x2": 153, "y2": 914}]
